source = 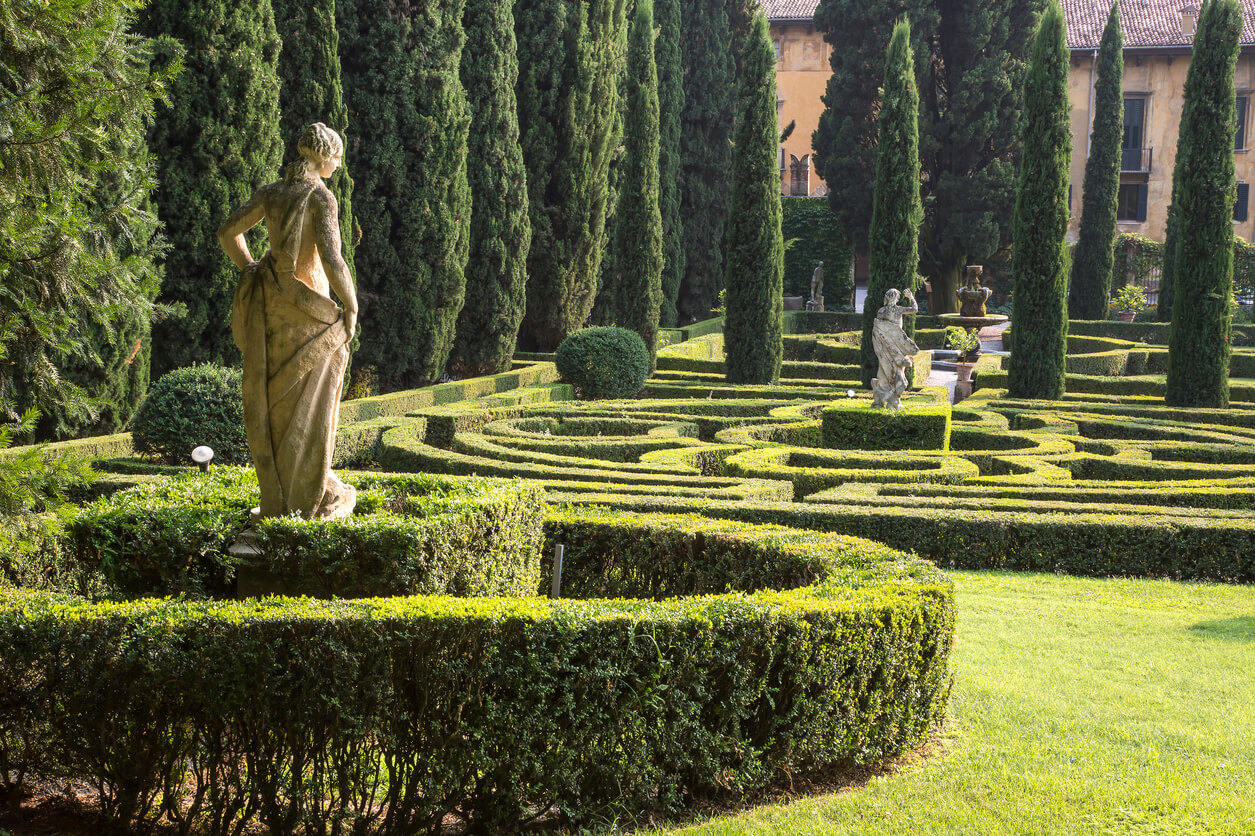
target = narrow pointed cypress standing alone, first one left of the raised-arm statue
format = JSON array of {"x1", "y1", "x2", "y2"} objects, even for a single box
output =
[{"x1": 723, "y1": 11, "x2": 784, "y2": 383}]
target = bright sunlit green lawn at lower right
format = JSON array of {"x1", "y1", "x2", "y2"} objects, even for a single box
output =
[{"x1": 656, "y1": 572, "x2": 1255, "y2": 836}]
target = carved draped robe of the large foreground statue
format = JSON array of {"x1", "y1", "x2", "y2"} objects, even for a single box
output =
[{"x1": 231, "y1": 182, "x2": 356, "y2": 520}]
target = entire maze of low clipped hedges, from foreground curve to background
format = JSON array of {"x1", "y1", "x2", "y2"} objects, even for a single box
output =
[{"x1": 9, "y1": 315, "x2": 1255, "y2": 833}]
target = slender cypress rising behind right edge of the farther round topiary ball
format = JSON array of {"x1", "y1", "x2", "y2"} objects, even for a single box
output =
[{"x1": 614, "y1": 0, "x2": 663, "y2": 370}]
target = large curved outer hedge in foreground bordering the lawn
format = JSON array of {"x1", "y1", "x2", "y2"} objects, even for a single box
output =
[{"x1": 0, "y1": 513, "x2": 955, "y2": 835}]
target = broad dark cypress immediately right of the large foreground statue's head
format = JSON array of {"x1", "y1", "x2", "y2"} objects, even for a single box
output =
[{"x1": 336, "y1": 0, "x2": 471, "y2": 390}]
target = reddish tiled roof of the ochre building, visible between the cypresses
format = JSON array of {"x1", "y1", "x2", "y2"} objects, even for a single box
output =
[{"x1": 762, "y1": 0, "x2": 1255, "y2": 49}]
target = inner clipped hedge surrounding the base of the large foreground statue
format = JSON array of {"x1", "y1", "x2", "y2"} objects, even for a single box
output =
[{"x1": 67, "y1": 467, "x2": 543, "y2": 598}]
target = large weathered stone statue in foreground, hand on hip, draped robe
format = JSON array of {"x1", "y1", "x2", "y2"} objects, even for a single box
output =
[{"x1": 218, "y1": 122, "x2": 358, "y2": 520}]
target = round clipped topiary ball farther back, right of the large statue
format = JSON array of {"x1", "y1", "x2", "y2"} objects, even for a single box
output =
[{"x1": 553, "y1": 326, "x2": 649, "y2": 399}]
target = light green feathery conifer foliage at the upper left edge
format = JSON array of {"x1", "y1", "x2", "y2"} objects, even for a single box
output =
[{"x1": 0, "y1": 0, "x2": 178, "y2": 434}]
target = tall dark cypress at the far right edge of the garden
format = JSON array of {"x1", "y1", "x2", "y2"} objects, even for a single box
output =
[{"x1": 1165, "y1": 0, "x2": 1242, "y2": 408}]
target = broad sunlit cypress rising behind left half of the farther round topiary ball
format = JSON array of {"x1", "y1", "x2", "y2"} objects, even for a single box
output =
[{"x1": 515, "y1": 0, "x2": 625, "y2": 351}]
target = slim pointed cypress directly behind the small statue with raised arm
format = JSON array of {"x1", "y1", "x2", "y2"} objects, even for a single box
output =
[{"x1": 861, "y1": 18, "x2": 924, "y2": 387}]
